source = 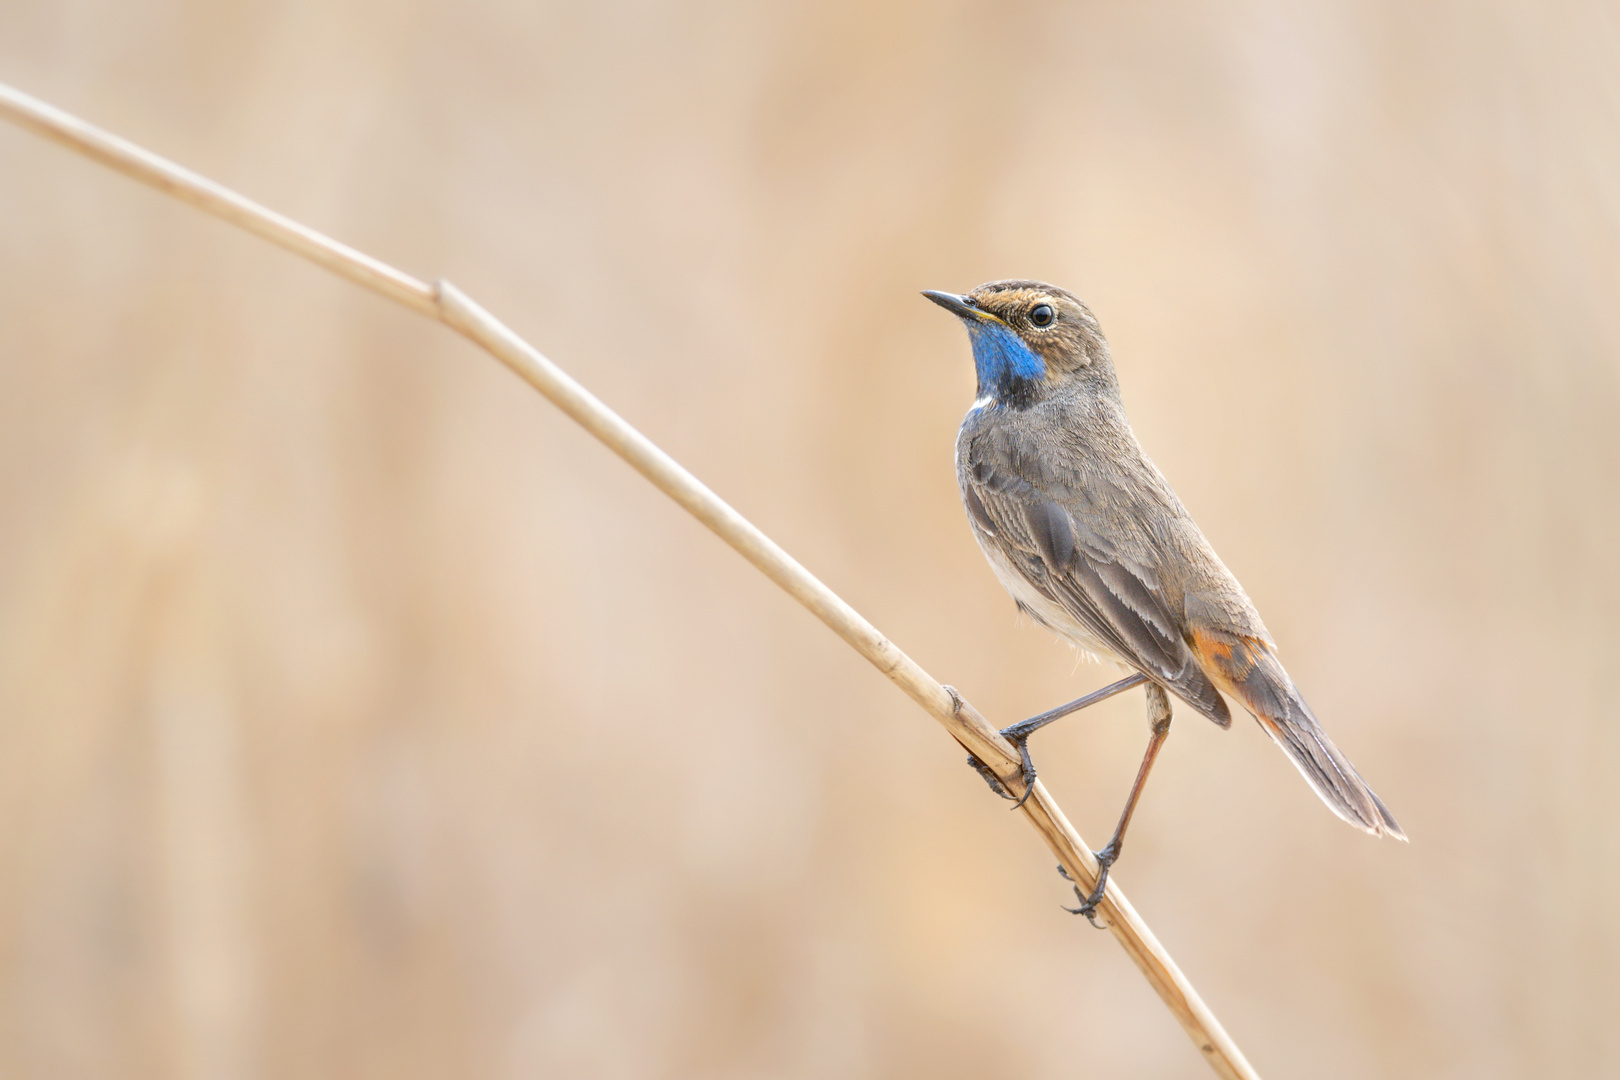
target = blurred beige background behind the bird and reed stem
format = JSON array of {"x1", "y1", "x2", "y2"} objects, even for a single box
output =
[{"x1": 0, "y1": 0, "x2": 1620, "y2": 1080}]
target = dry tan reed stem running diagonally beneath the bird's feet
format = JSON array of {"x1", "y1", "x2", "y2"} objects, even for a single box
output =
[{"x1": 0, "y1": 83, "x2": 1257, "y2": 1078}]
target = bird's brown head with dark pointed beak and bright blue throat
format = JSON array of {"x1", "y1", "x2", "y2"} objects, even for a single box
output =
[{"x1": 923, "y1": 282, "x2": 1115, "y2": 408}]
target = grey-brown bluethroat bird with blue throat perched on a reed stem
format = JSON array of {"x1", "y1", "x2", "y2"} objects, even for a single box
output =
[{"x1": 923, "y1": 282, "x2": 1406, "y2": 918}]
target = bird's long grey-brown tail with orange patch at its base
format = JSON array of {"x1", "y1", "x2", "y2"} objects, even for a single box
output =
[{"x1": 1192, "y1": 630, "x2": 1406, "y2": 840}]
